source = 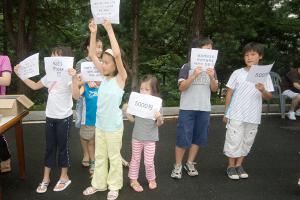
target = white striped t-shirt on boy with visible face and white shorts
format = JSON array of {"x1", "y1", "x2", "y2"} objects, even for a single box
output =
[{"x1": 225, "y1": 68, "x2": 274, "y2": 124}]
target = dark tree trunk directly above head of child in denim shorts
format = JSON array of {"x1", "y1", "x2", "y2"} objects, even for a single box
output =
[{"x1": 190, "y1": 0, "x2": 206, "y2": 39}]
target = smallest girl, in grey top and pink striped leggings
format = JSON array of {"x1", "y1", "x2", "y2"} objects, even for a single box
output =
[{"x1": 124, "y1": 75, "x2": 163, "y2": 192}]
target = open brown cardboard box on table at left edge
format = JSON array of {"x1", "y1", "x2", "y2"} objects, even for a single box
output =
[{"x1": 0, "y1": 95, "x2": 34, "y2": 116}]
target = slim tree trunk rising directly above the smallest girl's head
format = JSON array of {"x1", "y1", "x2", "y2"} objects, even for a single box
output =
[{"x1": 131, "y1": 0, "x2": 140, "y2": 91}]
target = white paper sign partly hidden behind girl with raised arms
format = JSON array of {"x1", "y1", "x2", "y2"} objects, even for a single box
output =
[{"x1": 81, "y1": 62, "x2": 103, "y2": 82}]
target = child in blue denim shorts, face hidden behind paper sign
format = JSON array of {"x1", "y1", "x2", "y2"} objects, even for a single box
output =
[{"x1": 171, "y1": 38, "x2": 218, "y2": 179}]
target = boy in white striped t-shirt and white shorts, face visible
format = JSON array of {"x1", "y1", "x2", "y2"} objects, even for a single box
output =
[{"x1": 224, "y1": 42, "x2": 274, "y2": 180}]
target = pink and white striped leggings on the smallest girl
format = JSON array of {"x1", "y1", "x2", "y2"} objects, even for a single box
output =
[{"x1": 128, "y1": 139, "x2": 156, "y2": 181}]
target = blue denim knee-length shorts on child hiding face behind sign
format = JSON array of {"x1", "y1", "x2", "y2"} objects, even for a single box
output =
[{"x1": 176, "y1": 110, "x2": 210, "y2": 149}]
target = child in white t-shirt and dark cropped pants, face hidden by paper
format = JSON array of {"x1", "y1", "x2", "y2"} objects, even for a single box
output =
[{"x1": 14, "y1": 47, "x2": 79, "y2": 193}]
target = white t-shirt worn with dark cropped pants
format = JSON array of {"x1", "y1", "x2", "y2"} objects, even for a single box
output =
[{"x1": 40, "y1": 76, "x2": 73, "y2": 119}]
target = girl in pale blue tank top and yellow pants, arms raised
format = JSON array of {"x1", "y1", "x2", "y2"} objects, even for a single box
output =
[{"x1": 83, "y1": 20, "x2": 127, "y2": 200}]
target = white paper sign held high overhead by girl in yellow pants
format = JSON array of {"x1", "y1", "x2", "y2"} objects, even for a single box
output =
[{"x1": 91, "y1": 0, "x2": 120, "y2": 24}]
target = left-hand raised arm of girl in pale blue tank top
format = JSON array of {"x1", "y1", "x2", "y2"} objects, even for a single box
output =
[{"x1": 89, "y1": 20, "x2": 103, "y2": 74}]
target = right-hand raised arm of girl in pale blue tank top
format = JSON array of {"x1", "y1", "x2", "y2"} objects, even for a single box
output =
[{"x1": 102, "y1": 20, "x2": 127, "y2": 88}]
